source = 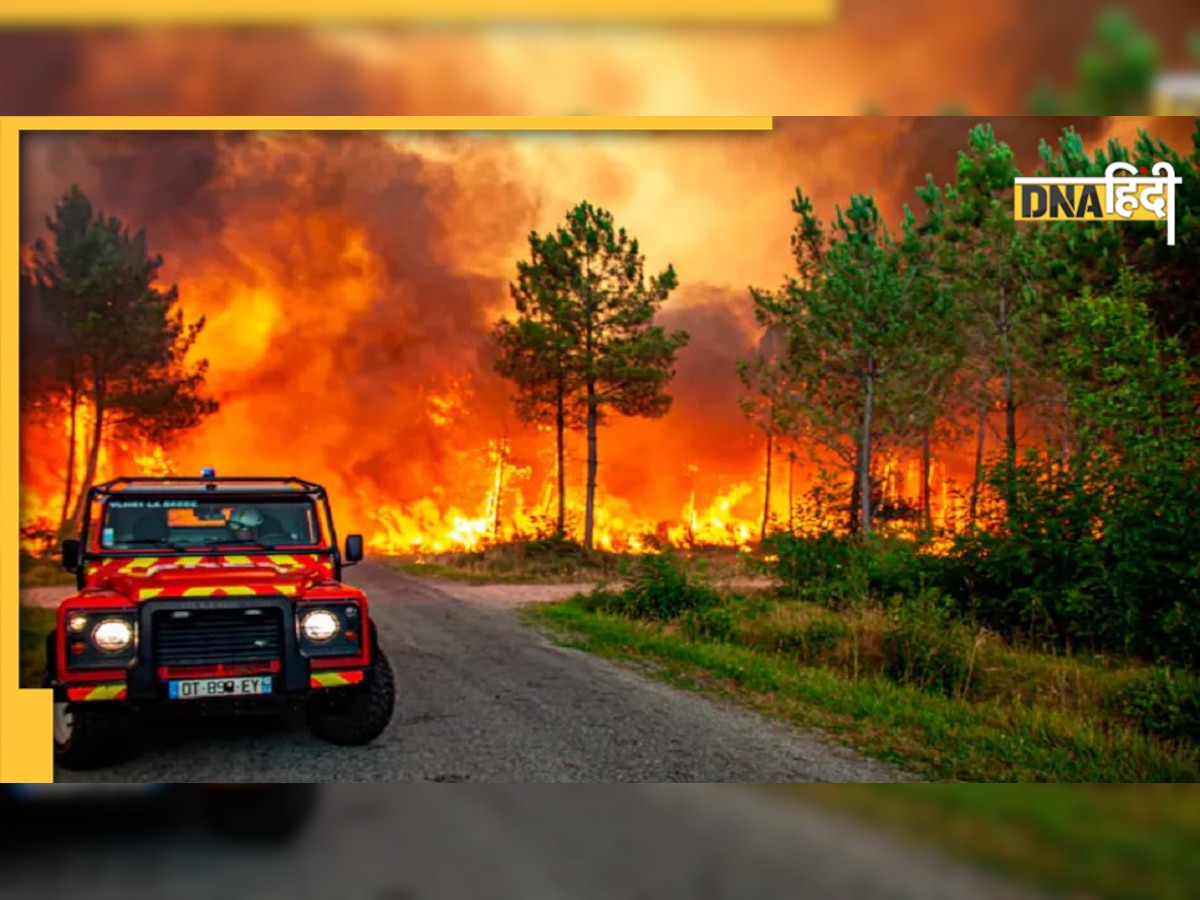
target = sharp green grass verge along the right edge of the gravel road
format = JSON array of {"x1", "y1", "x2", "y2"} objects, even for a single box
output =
[{"x1": 524, "y1": 595, "x2": 1200, "y2": 784}]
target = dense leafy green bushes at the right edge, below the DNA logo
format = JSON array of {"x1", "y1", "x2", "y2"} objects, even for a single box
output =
[{"x1": 940, "y1": 278, "x2": 1200, "y2": 666}]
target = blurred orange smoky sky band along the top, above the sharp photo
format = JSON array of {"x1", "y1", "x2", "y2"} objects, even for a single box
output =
[{"x1": 0, "y1": 0, "x2": 1200, "y2": 115}]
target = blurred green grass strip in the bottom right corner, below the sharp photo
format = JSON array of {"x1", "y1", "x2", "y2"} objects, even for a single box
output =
[{"x1": 764, "y1": 785, "x2": 1200, "y2": 900}]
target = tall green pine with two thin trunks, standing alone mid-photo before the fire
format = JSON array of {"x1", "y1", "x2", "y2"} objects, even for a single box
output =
[{"x1": 496, "y1": 202, "x2": 688, "y2": 550}]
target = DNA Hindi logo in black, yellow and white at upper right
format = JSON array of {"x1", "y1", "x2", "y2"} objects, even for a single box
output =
[{"x1": 1013, "y1": 162, "x2": 1183, "y2": 247}]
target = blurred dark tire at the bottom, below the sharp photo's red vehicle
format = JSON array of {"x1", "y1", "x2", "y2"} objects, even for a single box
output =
[{"x1": 202, "y1": 784, "x2": 318, "y2": 844}]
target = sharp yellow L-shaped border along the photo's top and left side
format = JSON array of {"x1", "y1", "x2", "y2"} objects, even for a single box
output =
[{"x1": 0, "y1": 112, "x2": 773, "y2": 784}]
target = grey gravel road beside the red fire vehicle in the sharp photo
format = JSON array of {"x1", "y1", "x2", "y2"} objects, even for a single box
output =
[{"x1": 49, "y1": 563, "x2": 910, "y2": 784}]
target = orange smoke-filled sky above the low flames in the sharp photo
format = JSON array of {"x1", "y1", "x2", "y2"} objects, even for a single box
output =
[{"x1": 22, "y1": 118, "x2": 1192, "y2": 549}]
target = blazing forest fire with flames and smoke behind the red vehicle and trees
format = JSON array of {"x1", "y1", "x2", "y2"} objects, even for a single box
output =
[{"x1": 22, "y1": 120, "x2": 1108, "y2": 554}]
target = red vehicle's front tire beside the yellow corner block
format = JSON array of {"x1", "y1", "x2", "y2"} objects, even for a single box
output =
[{"x1": 42, "y1": 631, "x2": 136, "y2": 772}]
